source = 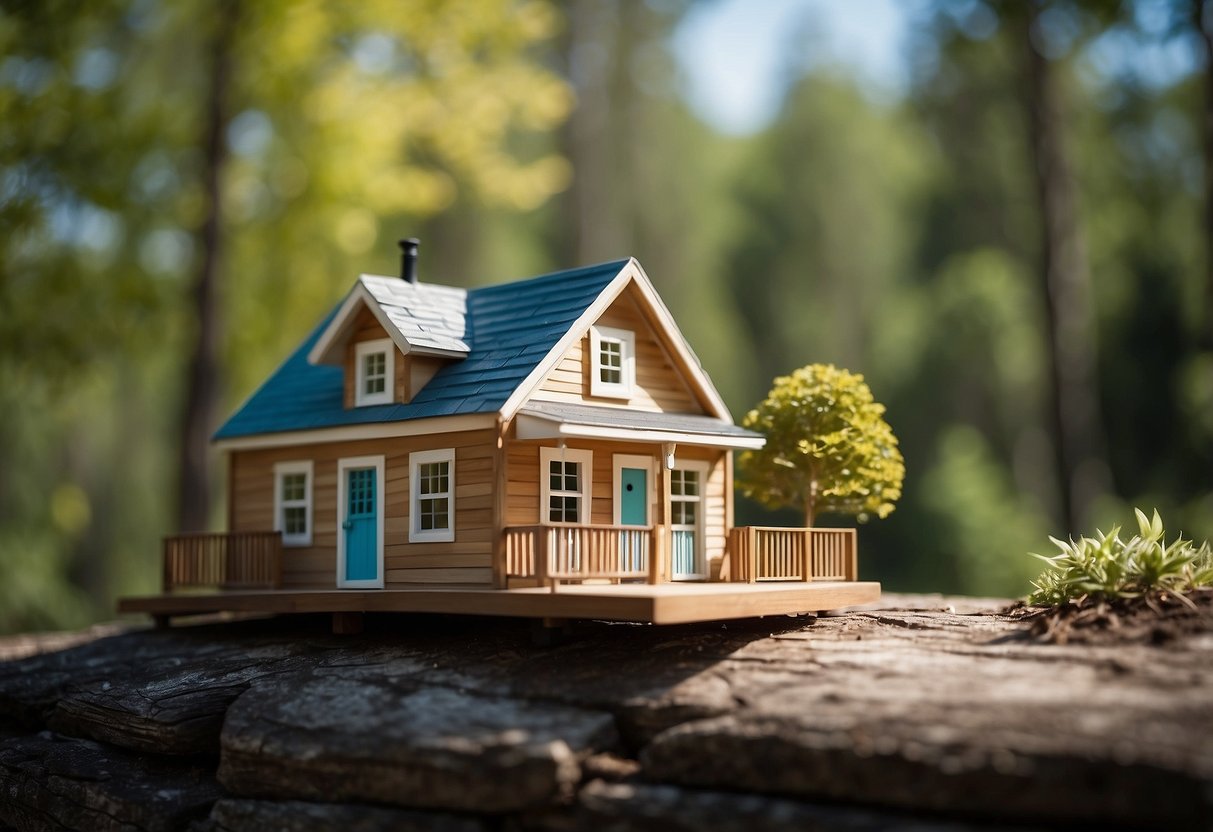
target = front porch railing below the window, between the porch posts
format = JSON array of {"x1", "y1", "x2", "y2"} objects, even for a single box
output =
[{"x1": 506, "y1": 525, "x2": 653, "y2": 592}]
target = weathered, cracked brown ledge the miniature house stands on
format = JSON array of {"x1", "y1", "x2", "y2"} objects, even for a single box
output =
[{"x1": 0, "y1": 595, "x2": 1213, "y2": 832}]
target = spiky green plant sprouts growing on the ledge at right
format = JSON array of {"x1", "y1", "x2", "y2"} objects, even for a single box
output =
[{"x1": 1027, "y1": 508, "x2": 1213, "y2": 606}]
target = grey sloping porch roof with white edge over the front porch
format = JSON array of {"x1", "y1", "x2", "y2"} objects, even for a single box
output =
[{"x1": 517, "y1": 401, "x2": 767, "y2": 450}]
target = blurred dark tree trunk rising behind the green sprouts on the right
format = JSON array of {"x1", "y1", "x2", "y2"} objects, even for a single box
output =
[{"x1": 1019, "y1": 2, "x2": 1109, "y2": 531}]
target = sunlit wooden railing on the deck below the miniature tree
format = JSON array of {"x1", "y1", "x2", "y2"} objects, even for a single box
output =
[{"x1": 729, "y1": 526, "x2": 859, "y2": 583}]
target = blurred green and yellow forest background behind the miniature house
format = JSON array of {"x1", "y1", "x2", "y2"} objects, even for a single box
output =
[{"x1": 0, "y1": 0, "x2": 1213, "y2": 632}]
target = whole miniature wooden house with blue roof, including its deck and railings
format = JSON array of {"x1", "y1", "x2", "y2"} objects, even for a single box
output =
[{"x1": 121, "y1": 240, "x2": 879, "y2": 622}]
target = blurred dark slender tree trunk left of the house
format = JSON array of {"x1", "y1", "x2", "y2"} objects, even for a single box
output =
[{"x1": 177, "y1": 0, "x2": 239, "y2": 531}]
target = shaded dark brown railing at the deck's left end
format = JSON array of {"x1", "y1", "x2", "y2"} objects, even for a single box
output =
[{"x1": 164, "y1": 531, "x2": 283, "y2": 592}]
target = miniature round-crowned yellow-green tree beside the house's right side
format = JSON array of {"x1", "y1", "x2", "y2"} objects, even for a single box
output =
[{"x1": 738, "y1": 364, "x2": 905, "y2": 526}]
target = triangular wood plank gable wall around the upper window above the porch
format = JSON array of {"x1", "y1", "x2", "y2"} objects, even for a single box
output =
[{"x1": 530, "y1": 286, "x2": 704, "y2": 414}]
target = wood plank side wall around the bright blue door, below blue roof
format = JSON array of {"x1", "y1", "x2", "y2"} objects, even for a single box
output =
[{"x1": 228, "y1": 429, "x2": 496, "y2": 588}]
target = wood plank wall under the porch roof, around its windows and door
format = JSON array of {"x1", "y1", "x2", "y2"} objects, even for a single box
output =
[{"x1": 506, "y1": 440, "x2": 729, "y2": 574}]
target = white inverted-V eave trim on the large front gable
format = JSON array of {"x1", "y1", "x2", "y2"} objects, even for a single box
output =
[{"x1": 501, "y1": 257, "x2": 733, "y2": 424}]
